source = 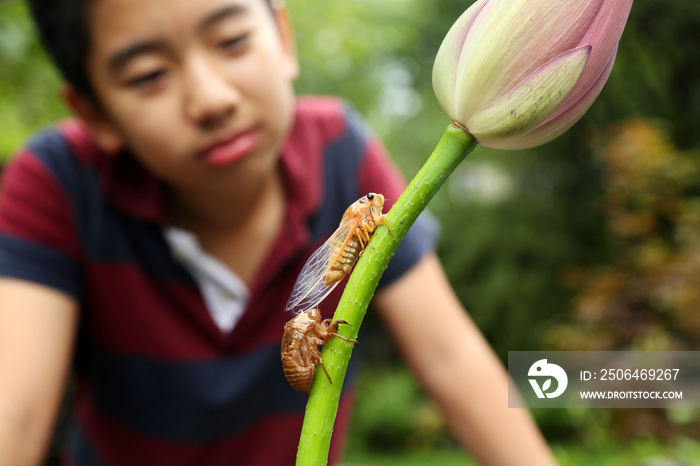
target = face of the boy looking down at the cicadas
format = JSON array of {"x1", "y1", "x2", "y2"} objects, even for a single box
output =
[{"x1": 79, "y1": 0, "x2": 298, "y2": 191}]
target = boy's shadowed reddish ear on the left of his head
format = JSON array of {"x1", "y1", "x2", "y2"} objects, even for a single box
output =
[{"x1": 62, "y1": 84, "x2": 124, "y2": 154}]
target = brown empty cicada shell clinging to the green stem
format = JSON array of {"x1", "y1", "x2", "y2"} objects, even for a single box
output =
[{"x1": 282, "y1": 309, "x2": 357, "y2": 395}]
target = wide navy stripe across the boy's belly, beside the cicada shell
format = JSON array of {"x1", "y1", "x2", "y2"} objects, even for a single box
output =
[{"x1": 92, "y1": 345, "x2": 357, "y2": 442}]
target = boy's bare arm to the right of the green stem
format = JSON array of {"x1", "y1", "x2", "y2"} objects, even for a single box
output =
[{"x1": 374, "y1": 254, "x2": 557, "y2": 466}]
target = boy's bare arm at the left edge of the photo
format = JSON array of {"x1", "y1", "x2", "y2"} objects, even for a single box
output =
[{"x1": 0, "y1": 278, "x2": 78, "y2": 466}]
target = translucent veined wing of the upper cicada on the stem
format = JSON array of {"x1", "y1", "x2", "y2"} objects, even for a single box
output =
[{"x1": 286, "y1": 221, "x2": 353, "y2": 314}]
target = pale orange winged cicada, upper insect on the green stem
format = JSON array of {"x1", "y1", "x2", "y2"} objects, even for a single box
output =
[{"x1": 286, "y1": 193, "x2": 396, "y2": 314}]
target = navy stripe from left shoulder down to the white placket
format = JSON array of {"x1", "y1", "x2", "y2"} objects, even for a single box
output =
[{"x1": 28, "y1": 130, "x2": 194, "y2": 284}]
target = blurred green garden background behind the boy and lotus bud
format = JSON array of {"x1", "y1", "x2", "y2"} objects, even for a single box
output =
[{"x1": 0, "y1": 0, "x2": 700, "y2": 466}]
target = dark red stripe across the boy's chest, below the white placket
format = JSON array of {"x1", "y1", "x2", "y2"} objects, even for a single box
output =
[{"x1": 84, "y1": 258, "x2": 347, "y2": 360}]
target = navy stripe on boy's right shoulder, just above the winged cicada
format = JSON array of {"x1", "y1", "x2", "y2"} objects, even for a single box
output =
[{"x1": 309, "y1": 103, "x2": 367, "y2": 242}]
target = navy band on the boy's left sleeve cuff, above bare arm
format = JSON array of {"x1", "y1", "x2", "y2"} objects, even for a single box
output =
[{"x1": 0, "y1": 233, "x2": 85, "y2": 300}]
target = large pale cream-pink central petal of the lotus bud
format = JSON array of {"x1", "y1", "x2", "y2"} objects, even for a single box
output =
[{"x1": 457, "y1": 0, "x2": 605, "y2": 122}]
